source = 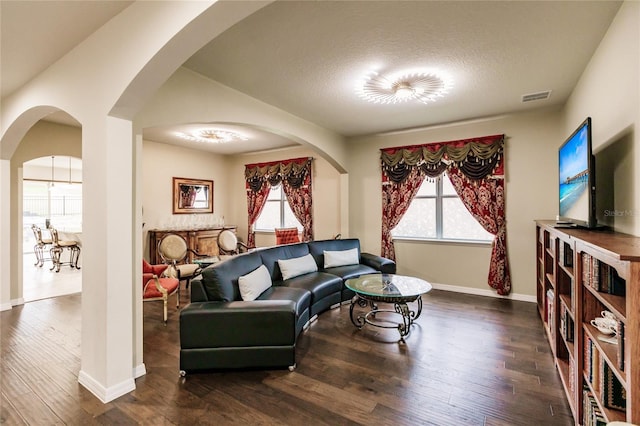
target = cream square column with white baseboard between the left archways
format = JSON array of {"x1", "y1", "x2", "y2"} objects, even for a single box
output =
[{"x1": 78, "y1": 116, "x2": 135, "y2": 402}]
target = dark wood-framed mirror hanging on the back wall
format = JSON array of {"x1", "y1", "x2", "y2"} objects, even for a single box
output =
[{"x1": 173, "y1": 177, "x2": 213, "y2": 214}]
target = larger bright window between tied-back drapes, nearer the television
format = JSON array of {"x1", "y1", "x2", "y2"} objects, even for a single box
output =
[{"x1": 391, "y1": 173, "x2": 493, "y2": 241}]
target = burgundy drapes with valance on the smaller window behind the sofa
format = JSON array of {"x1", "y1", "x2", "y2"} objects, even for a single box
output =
[{"x1": 245, "y1": 157, "x2": 313, "y2": 247}]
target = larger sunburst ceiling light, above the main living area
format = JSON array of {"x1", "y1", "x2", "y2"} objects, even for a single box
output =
[{"x1": 356, "y1": 71, "x2": 453, "y2": 104}]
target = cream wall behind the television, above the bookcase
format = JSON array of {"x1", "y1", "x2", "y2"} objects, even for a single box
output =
[{"x1": 564, "y1": 1, "x2": 640, "y2": 235}]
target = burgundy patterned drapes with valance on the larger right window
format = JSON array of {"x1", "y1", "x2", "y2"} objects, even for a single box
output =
[{"x1": 380, "y1": 135, "x2": 511, "y2": 295}]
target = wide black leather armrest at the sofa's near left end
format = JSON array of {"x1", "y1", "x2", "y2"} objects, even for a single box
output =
[{"x1": 180, "y1": 300, "x2": 296, "y2": 349}]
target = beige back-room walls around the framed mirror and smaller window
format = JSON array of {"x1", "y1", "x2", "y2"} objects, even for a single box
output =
[{"x1": 141, "y1": 141, "x2": 340, "y2": 259}]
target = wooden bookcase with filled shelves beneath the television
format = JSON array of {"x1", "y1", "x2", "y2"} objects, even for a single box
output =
[{"x1": 536, "y1": 221, "x2": 640, "y2": 425}]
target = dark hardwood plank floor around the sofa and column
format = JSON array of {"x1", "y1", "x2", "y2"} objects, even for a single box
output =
[{"x1": 0, "y1": 290, "x2": 573, "y2": 425}]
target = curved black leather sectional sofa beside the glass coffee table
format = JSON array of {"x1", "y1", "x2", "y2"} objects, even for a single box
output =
[{"x1": 180, "y1": 239, "x2": 396, "y2": 375}]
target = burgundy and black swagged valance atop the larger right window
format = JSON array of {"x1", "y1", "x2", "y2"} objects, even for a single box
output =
[{"x1": 380, "y1": 135, "x2": 504, "y2": 183}]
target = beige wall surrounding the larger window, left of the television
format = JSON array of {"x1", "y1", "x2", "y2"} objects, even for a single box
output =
[{"x1": 349, "y1": 110, "x2": 563, "y2": 298}]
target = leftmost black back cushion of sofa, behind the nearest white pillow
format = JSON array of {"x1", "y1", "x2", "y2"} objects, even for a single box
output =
[{"x1": 202, "y1": 253, "x2": 262, "y2": 302}]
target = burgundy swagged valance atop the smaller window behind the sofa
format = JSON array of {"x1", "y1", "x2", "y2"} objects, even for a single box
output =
[{"x1": 244, "y1": 157, "x2": 313, "y2": 192}]
